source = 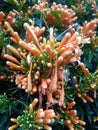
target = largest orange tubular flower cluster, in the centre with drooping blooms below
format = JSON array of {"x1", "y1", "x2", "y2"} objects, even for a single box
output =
[{"x1": 4, "y1": 21, "x2": 81, "y2": 105}]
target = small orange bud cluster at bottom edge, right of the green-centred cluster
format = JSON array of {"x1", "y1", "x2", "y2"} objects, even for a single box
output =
[{"x1": 57, "y1": 101, "x2": 86, "y2": 130}]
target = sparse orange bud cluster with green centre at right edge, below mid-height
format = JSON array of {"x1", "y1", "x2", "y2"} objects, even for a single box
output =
[{"x1": 73, "y1": 63, "x2": 98, "y2": 103}]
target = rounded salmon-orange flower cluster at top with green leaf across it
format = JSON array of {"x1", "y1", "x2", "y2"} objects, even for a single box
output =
[{"x1": 35, "y1": 2, "x2": 77, "y2": 28}]
